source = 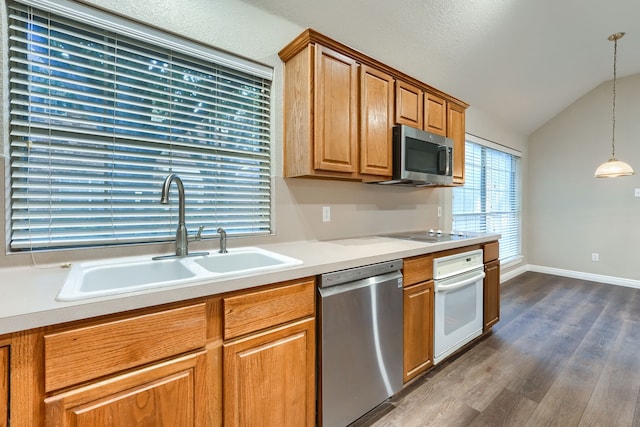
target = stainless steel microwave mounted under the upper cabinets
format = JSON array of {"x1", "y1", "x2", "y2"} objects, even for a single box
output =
[{"x1": 377, "y1": 125, "x2": 454, "y2": 187}]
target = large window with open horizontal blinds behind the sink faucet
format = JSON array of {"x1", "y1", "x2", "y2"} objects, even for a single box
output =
[{"x1": 7, "y1": 0, "x2": 272, "y2": 251}]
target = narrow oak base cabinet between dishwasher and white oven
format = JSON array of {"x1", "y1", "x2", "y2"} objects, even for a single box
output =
[{"x1": 402, "y1": 255, "x2": 434, "y2": 382}]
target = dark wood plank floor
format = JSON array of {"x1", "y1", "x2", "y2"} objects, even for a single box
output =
[{"x1": 355, "y1": 272, "x2": 640, "y2": 427}]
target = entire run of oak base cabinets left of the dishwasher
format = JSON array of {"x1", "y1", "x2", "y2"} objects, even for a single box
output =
[{"x1": 0, "y1": 277, "x2": 315, "y2": 427}]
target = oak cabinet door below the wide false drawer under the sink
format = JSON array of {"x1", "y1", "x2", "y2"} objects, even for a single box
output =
[{"x1": 45, "y1": 352, "x2": 207, "y2": 427}]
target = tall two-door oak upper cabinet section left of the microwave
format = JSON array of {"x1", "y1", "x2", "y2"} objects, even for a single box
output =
[{"x1": 284, "y1": 39, "x2": 393, "y2": 180}]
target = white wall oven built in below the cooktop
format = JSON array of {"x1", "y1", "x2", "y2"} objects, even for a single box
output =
[{"x1": 433, "y1": 249, "x2": 484, "y2": 365}]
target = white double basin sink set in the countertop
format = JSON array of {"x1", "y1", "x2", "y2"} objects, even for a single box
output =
[{"x1": 56, "y1": 247, "x2": 302, "y2": 301}]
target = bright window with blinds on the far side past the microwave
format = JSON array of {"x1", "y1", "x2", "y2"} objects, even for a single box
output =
[{"x1": 452, "y1": 135, "x2": 520, "y2": 262}]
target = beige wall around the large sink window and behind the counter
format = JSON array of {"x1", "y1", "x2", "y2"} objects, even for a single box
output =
[{"x1": 0, "y1": 0, "x2": 524, "y2": 266}]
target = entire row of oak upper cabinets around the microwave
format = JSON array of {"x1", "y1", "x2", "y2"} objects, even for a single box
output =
[{"x1": 279, "y1": 29, "x2": 468, "y2": 181}]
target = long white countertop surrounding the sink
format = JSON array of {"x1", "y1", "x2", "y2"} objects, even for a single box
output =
[{"x1": 0, "y1": 234, "x2": 499, "y2": 334}]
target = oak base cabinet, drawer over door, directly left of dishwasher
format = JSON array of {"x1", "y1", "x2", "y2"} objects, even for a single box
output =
[{"x1": 223, "y1": 278, "x2": 315, "y2": 426}]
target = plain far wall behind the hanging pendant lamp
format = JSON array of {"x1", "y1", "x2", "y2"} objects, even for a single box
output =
[{"x1": 526, "y1": 74, "x2": 640, "y2": 280}]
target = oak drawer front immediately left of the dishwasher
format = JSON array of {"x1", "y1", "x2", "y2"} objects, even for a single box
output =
[{"x1": 222, "y1": 278, "x2": 316, "y2": 340}]
